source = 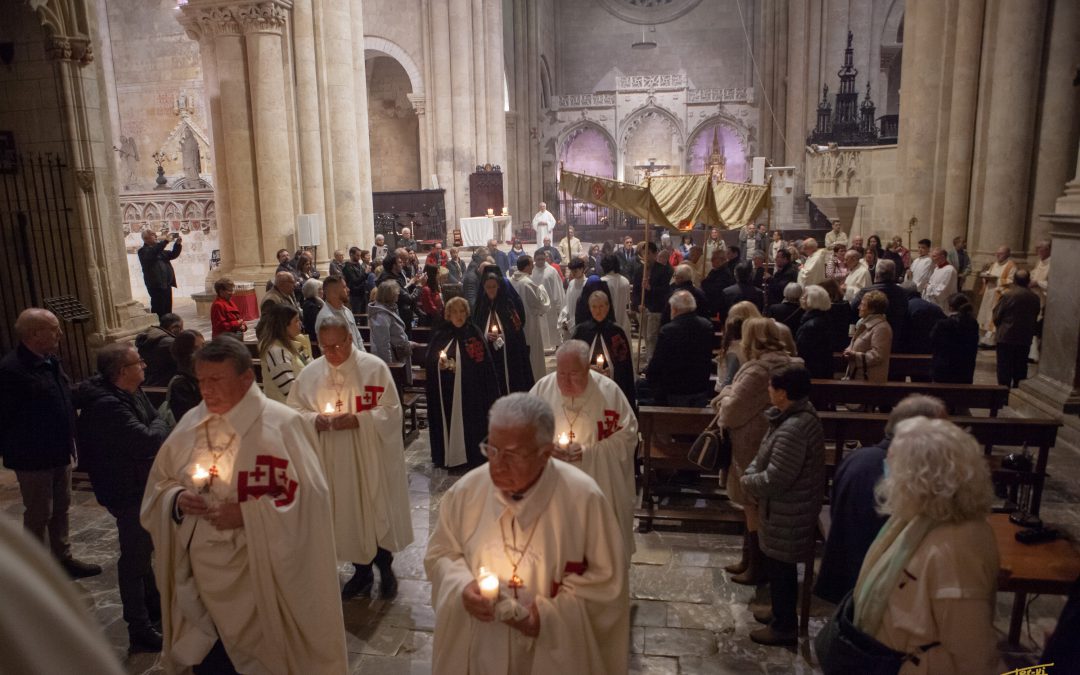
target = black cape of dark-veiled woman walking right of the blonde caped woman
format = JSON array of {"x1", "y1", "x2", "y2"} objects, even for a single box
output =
[{"x1": 468, "y1": 278, "x2": 536, "y2": 395}]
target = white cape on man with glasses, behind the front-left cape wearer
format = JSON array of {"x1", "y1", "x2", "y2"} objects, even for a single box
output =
[{"x1": 288, "y1": 350, "x2": 413, "y2": 563}]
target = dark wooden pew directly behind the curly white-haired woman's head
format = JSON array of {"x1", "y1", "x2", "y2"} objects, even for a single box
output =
[{"x1": 819, "y1": 411, "x2": 1062, "y2": 515}]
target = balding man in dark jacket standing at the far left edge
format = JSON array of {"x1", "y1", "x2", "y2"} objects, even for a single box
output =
[{"x1": 0, "y1": 308, "x2": 102, "y2": 579}]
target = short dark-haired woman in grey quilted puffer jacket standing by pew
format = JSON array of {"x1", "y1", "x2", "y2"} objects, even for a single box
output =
[{"x1": 742, "y1": 365, "x2": 825, "y2": 646}]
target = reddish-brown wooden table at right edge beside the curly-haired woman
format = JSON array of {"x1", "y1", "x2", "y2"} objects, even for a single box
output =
[{"x1": 988, "y1": 513, "x2": 1080, "y2": 645}]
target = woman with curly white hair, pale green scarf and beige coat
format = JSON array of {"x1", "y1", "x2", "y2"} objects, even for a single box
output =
[{"x1": 853, "y1": 417, "x2": 998, "y2": 675}]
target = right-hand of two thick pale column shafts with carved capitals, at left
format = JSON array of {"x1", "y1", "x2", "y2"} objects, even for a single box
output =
[{"x1": 238, "y1": 2, "x2": 299, "y2": 271}]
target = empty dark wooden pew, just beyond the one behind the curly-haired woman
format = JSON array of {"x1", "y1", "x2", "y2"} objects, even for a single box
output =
[{"x1": 810, "y1": 379, "x2": 1009, "y2": 417}]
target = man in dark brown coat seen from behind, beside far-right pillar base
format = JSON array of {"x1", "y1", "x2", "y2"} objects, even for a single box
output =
[{"x1": 994, "y1": 270, "x2": 1041, "y2": 387}]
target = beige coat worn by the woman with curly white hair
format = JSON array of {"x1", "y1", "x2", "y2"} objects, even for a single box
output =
[{"x1": 875, "y1": 521, "x2": 999, "y2": 675}]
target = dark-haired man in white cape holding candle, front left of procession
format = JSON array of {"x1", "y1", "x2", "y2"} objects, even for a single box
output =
[{"x1": 140, "y1": 336, "x2": 348, "y2": 674}]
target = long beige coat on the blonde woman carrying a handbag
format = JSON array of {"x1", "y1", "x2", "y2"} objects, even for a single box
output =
[{"x1": 716, "y1": 352, "x2": 802, "y2": 504}]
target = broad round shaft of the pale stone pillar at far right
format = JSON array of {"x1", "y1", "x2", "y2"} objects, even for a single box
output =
[{"x1": 967, "y1": 0, "x2": 1047, "y2": 262}]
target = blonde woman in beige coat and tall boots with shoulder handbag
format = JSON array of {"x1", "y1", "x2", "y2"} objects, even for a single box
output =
[{"x1": 713, "y1": 318, "x2": 802, "y2": 585}]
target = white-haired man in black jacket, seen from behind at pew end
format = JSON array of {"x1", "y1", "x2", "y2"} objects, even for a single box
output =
[{"x1": 637, "y1": 291, "x2": 714, "y2": 407}]
